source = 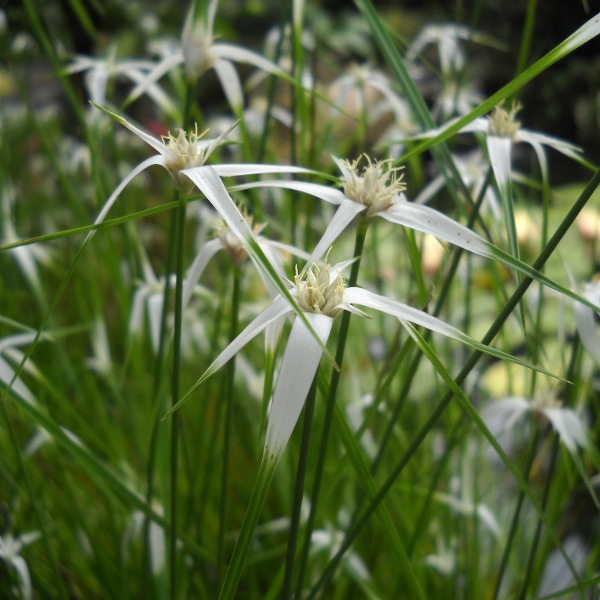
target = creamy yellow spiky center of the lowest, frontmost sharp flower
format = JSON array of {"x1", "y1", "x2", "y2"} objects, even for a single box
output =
[{"x1": 294, "y1": 263, "x2": 346, "y2": 317}]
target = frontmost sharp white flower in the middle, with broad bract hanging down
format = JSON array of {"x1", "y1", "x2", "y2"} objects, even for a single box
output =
[{"x1": 168, "y1": 259, "x2": 549, "y2": 464}]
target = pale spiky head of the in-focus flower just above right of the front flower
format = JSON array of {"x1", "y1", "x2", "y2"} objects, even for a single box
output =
[{"x1": 340, "y1": 154, "x2": 406, "y2": 219}]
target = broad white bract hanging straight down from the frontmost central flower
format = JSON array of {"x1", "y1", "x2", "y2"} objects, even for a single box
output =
[{"x1": 264, "y1": 313, "x2": 333, "y2": 462}]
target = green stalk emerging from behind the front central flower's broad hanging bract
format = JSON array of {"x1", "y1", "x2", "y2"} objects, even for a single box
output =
[{"x1": 281, "y1": 371, "x2": 319, "y2": 600}]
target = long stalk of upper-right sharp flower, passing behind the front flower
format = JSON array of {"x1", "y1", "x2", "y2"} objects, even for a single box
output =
[{"x1": 296, "y1": 221, "x2": 369, "y2": 598}]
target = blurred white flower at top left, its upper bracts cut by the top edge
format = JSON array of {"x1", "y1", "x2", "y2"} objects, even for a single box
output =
[{"x1": 128, "y1": 0, "x2": 285, "y2": 114}]
